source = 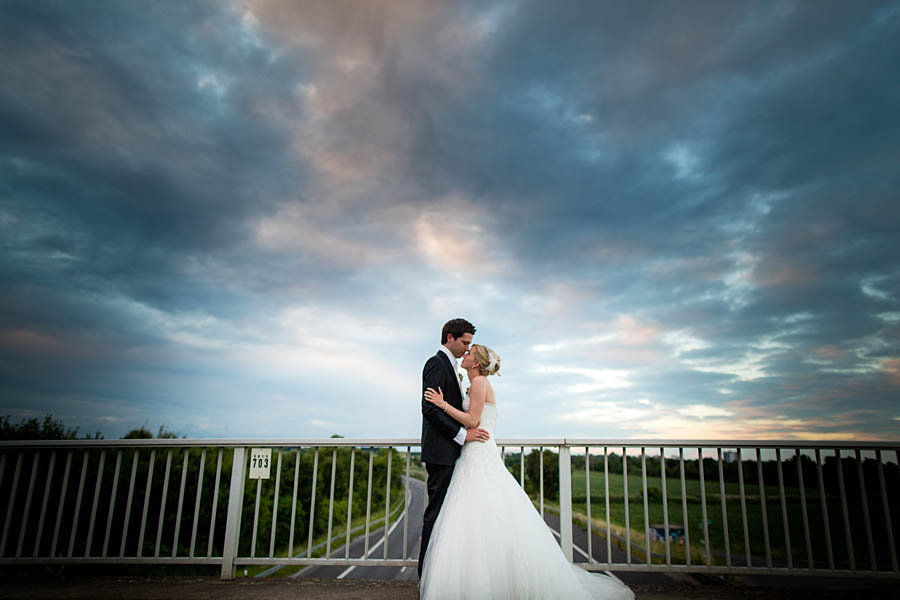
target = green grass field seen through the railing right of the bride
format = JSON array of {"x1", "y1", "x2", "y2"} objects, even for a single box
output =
[{"x1": 572, "y1": 469, "x2": 896, "y2": 568}]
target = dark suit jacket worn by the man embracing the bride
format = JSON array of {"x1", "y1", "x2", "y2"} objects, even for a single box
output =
[{"x1": 422, "y1": 350, "x2": 462, "y2": 466}]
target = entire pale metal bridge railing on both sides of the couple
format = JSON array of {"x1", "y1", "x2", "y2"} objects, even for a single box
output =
[{"x1": 0, "y1": 438, "x2": 900, "y2": 579}]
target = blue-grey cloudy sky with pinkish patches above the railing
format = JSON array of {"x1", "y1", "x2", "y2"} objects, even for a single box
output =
[{"x1": 0, "y1": 0, "x2": 900, "y2": 439}]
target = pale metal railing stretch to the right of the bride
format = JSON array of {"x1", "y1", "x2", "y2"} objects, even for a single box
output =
[{"x1": 498, "y1": 438, "x2": 900, "y2": 578}]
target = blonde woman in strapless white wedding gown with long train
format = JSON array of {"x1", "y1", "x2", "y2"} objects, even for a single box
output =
[{"x1": 419, "y1": 344, "x2": 634, "y2": 600}]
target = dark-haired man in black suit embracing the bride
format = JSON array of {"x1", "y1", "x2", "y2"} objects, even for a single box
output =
[{"x1": 418, "y1": 319, "x2": 488, "y2": 578}]
